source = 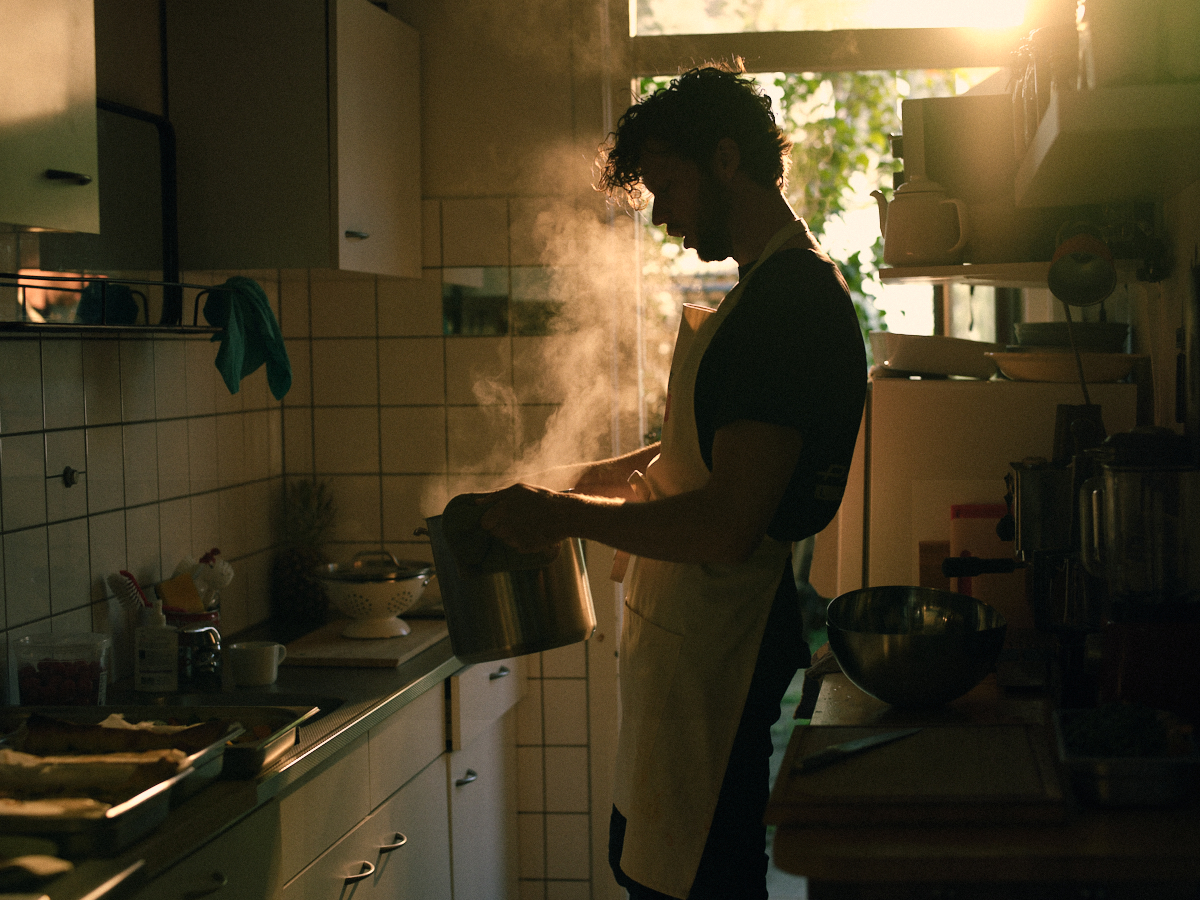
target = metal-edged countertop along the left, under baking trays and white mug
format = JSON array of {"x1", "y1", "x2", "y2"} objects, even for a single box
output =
[{"x1": 35, "y1": 623, "x2": 464, "y2": 900}]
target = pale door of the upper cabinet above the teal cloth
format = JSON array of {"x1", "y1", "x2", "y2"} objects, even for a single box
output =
[{"x1": 335, "y1": 0, "x2": 421, "y2": 278}]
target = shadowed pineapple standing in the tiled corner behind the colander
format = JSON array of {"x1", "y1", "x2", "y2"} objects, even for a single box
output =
[{"x1": 270, "y1": 479, "x2": 335, "y2": 642}]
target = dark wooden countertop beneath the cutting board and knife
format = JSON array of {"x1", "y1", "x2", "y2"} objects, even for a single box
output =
[{"x1": 774, "y1": 673, "x2": 1200, "y2": 900}]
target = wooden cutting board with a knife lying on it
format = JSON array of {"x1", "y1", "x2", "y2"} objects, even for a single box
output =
[{"x1": 767, "y1": 725, "x2": 1067, "y2": 826}]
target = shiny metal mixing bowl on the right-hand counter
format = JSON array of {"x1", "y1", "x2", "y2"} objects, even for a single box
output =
[{"x1": 827, "y1": 587, "x2": 1007, "y2": 707}]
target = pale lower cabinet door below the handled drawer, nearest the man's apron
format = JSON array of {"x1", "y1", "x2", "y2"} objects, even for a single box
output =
[{"x1": 446, "y1": 712, "x2": 517, "y2": 900}]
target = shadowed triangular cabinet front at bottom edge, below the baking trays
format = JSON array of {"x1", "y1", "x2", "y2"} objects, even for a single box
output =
[{"x1": 132, "y1": 803, "x2": 282, "y2": 900}]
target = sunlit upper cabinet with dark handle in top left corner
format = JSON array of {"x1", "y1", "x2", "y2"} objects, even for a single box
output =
[{"x1": 0, "y1": 0, "x2": 100, "y2": 233}]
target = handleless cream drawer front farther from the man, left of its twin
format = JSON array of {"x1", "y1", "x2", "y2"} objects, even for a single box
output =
[{"x1": 280, "y1": 734, "x2": 371, "y2": 880}]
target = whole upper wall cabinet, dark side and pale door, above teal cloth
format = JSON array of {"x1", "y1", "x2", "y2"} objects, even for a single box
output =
[{"x1": 166, "y1": 0, "x2": 421, "y2": 277}]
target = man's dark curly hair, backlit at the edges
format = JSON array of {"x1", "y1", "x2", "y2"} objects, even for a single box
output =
[{"x1": 596, "y1": 58, "x2": 792, "y2": 209}]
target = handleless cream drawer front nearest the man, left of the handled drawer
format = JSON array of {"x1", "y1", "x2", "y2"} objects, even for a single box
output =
[{"x1": 370, "y1": 683, "x2": 446, "y2": 809}]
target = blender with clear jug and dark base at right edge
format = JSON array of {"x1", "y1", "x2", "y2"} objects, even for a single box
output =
[{"x1": 1080, "y1": 434, "x2": 1200, "y2": 721}]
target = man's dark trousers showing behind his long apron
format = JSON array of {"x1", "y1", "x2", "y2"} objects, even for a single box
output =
[{"x1": 608, "y1": 560, "x2": 809, "y2": 900}]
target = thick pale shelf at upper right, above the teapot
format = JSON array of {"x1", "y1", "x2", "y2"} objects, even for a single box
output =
[{"x1": 1016, "y1": 84, "x2": 1200, "y2": 206}]
